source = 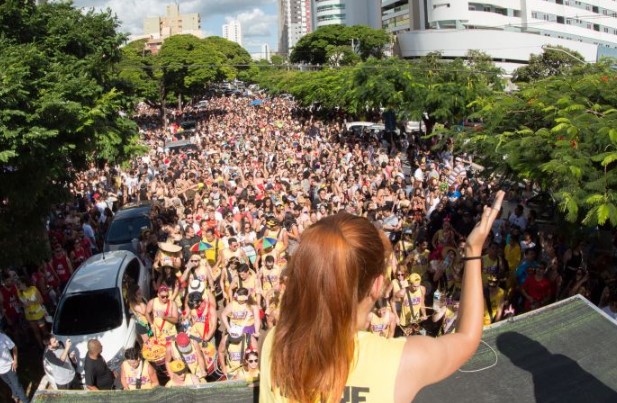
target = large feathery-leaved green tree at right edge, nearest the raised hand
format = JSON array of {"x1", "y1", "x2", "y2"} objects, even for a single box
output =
[{"x1": 462, "y1": 61, "x2": 617, "y2": 226}]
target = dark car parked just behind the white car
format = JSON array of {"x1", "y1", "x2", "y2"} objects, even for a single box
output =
[{"x1": 103, "y1": 202, "x2": 152, "y2": 254}]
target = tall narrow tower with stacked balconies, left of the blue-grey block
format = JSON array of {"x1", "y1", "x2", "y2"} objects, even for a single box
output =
[{"x1": 278, "y1": 0, "x2": 313, "y2": 56}]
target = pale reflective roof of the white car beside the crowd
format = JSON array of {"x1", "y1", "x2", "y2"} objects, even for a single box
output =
[{"x1": 64, "y1": 250, "x2": 136, "y2": 294}]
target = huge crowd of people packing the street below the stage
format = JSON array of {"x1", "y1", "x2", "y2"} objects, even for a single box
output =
[{"x1": 0, "y1": 90, "x2": 617, "y2": 400}]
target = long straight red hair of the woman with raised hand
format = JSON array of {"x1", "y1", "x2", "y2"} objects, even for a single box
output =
[{"x1": 271, "y1": 213, "x2": 387, "y2": 402}]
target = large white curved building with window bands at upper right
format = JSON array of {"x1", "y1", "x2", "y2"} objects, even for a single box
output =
[{"x1": 392, "y1": 0, "x2": 617, "y2": 72}]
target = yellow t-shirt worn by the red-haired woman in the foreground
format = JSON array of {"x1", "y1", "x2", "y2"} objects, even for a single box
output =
[{"x1": 259, "y1": 328, "x2": 407, "y2": 403}]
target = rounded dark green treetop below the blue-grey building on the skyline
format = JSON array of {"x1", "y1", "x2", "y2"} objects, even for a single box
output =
[{"x1": 289, "y1": 25, "x2": 390, "y2": 65}]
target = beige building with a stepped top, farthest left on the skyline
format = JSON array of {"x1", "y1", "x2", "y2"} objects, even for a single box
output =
[{"x1": 144, "y1": 3, "x2": 204, "y2": 40}]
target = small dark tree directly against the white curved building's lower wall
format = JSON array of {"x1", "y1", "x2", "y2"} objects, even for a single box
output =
[{"x1": 512, "y1": 46, "x2": 585, "y2": 83}]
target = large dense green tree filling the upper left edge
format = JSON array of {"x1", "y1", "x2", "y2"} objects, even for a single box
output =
[{"x1": 0, "y1": 0, "x2": 143, "y2": 264}]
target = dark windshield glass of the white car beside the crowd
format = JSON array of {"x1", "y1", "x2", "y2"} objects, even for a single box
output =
[{"x1": 53, "y1": 288, "x2": 122, "y2": 336}]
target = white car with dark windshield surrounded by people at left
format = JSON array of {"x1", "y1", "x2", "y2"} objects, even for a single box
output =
[{"x1": 52, "y1": 250, "x2": 150, "y2": 373}]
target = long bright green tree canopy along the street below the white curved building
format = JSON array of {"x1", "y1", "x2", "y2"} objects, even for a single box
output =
[{"x1": 256, "y1": 51, "x2": 503, "y2": 131}]
